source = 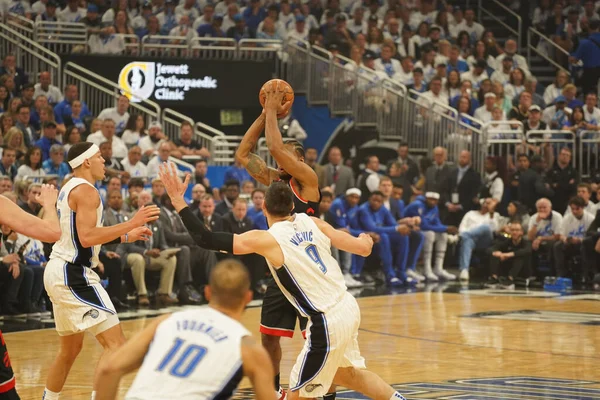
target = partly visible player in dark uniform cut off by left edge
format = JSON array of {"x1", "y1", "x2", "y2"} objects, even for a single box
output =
[{"x1": 0, "y1": 185, "x2": 60, "y2": 400}]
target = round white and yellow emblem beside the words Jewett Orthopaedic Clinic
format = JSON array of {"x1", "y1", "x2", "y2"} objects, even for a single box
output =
[{"x1": 119, "y1": 61, "x2": 156, "y2": 103}]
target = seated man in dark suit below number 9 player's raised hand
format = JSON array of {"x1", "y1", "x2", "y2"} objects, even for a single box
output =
[{"x1": 159, "y1": 193, "x2": 217, "y2": 304}]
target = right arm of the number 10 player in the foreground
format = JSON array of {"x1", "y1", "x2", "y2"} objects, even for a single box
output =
[{"x1": 242, "y1": 336, "x2": 277, "y2": 400}]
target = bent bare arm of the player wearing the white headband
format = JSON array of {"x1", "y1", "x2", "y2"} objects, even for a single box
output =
[{"x1": 68, "y1": 185, "x2": 160, "y2": 247}]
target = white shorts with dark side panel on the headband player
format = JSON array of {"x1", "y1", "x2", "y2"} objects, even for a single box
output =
[{"x1": 44, "y1": 258, "x2": 119, "y2": 336}]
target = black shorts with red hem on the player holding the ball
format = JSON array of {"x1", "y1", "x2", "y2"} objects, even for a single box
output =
[{"x1": 260, "y1": 279, "x2": 308, "y2": 338}]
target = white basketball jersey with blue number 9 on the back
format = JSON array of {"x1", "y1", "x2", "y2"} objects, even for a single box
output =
[{"x1": 268, "y1": 214, "x2": 346, "y2": 316}]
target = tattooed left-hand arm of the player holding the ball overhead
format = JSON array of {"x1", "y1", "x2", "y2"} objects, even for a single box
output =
[{"x1": 235, "y1": 113, "x2": 279, "y2": 186}]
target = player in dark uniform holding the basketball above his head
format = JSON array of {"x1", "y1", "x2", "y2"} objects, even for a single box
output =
[{"x1": 235, "y1": 85, "x2": 321, "y2": 399}]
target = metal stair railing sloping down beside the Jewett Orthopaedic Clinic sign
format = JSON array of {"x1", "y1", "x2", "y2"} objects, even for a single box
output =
[{"x1": 62, "y1": 62, "x2": 161, "y2": 126}]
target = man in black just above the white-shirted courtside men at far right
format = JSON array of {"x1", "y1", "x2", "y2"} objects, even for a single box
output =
[{"x1": 546, "y1": 146, "x2": 579, "y2": 211}]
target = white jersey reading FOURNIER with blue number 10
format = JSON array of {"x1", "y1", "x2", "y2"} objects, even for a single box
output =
[{"x1": 125, "y1": 306, "x2": 251, "y2": 400}]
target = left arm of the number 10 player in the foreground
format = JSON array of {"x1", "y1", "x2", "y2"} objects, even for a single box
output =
[{"x1": 94, "y1": 314, "x2": 170, "y2": 400}]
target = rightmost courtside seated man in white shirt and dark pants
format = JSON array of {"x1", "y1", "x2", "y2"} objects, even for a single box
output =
[{"x1": 554, "y1": 197, "x2": 594, "y2": 277}]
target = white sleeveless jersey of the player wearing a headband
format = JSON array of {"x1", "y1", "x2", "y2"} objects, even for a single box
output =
[{"x1": 50, "y1": 178, "x2": 104, "y2": 268}]
